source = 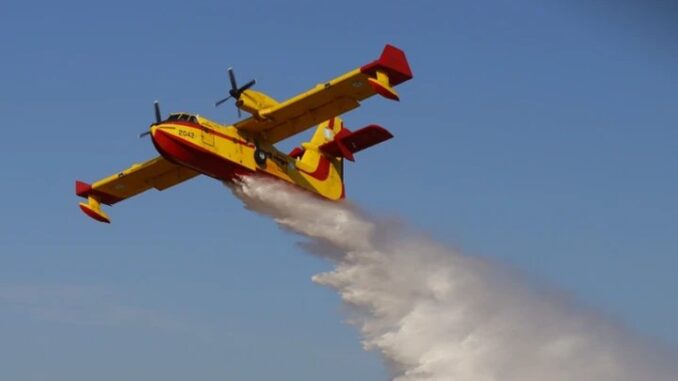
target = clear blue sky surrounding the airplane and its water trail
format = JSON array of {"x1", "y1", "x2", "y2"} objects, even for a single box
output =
[{"x1": 0, "y1": 0, "x2": 678, "y2": 381}]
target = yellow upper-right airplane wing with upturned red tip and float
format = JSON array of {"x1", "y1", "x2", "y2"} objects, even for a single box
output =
[{"x1": 235, "y1": 45, "x2": 412, "y2": 144}]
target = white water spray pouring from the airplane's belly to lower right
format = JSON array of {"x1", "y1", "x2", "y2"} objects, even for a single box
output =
[{"x1": 232, "y1": 178, "x2": 678, "y2": 381}]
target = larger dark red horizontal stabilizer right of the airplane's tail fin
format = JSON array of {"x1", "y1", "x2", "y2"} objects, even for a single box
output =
[{"x1": 319, "y1": 124, "x2": 393, "y2": 161}]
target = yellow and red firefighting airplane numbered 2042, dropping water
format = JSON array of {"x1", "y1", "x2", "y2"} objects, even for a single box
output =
[{"x1": 75, "y1": 45, "x2": 412, "y2": 223}]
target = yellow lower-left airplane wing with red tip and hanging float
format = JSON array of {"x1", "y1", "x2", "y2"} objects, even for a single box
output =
[{"x1": 75, "y1": 157, "x2": 199, "y2": 223}]
